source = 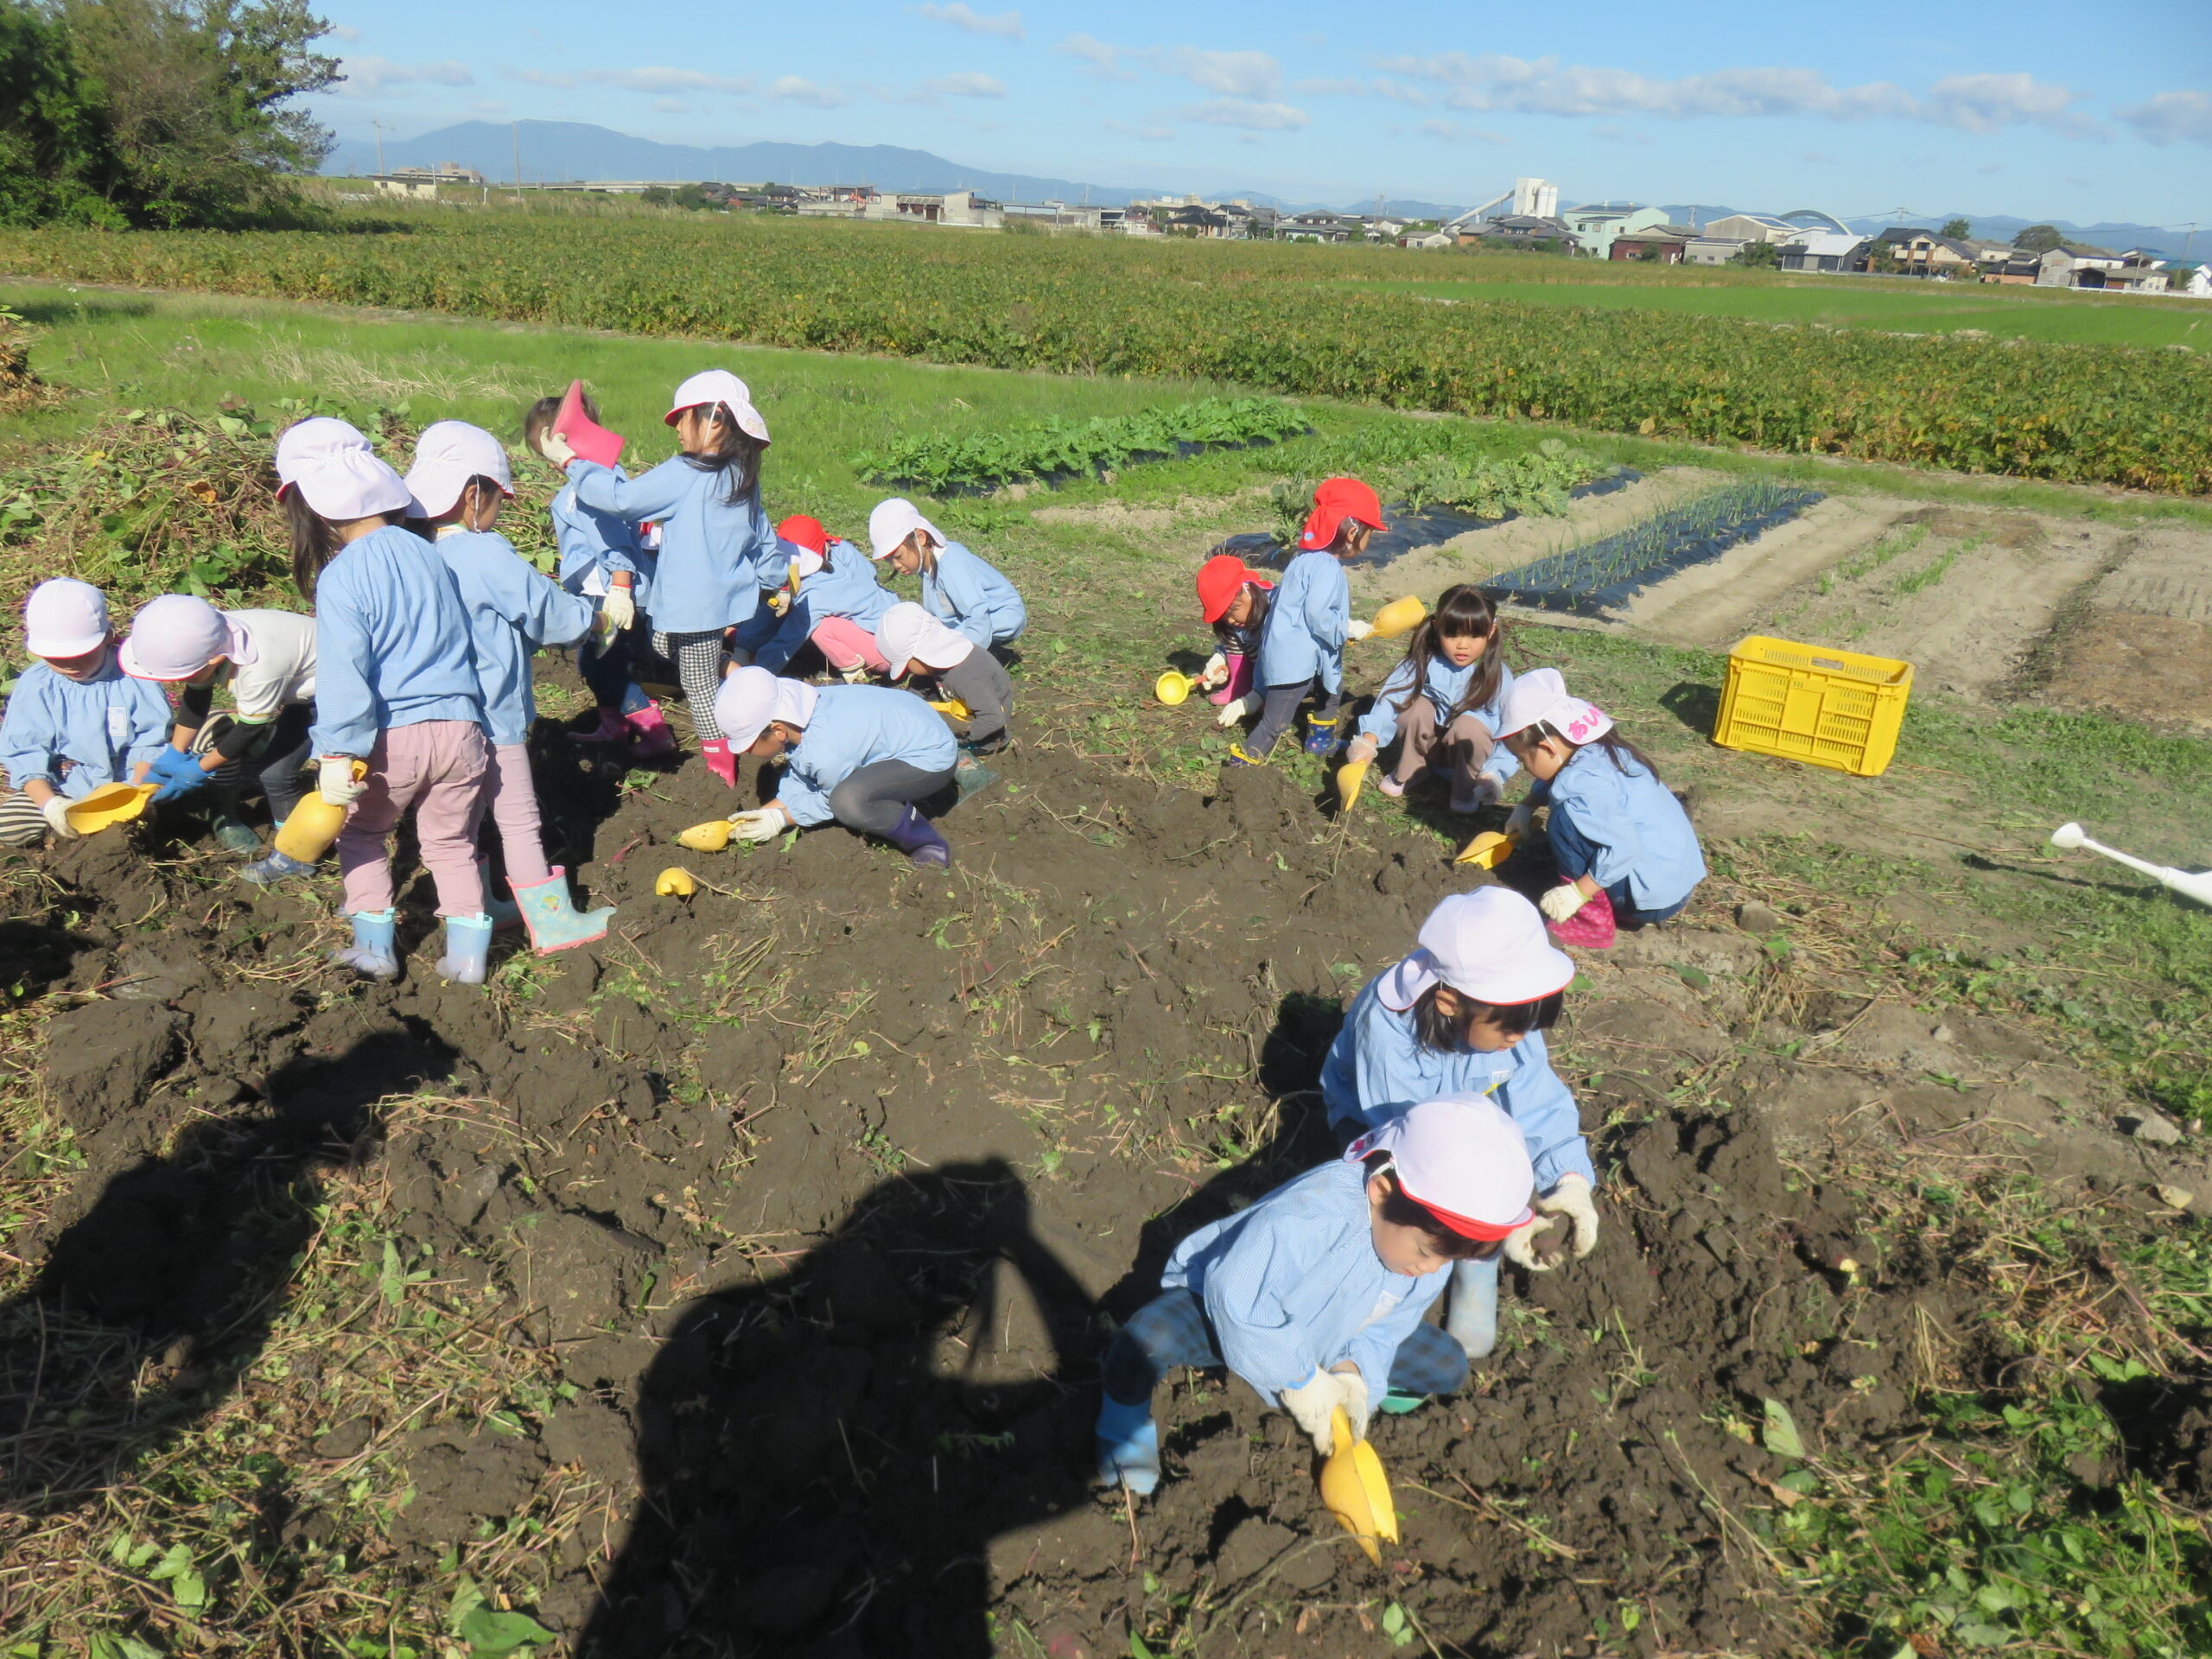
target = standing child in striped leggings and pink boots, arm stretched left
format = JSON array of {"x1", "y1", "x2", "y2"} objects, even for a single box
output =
[{"x1": 542, "y1": 370, "x2": 783, "y2": 790}]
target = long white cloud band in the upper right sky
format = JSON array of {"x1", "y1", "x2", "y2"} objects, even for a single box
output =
[{"x1": 1378, "y1": 51, "x2": 2097, "y2": 135}]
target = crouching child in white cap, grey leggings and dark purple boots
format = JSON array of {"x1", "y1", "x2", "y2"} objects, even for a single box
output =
[{"x1": 715, "y1": 668, "x2": 960, "y2": 869}]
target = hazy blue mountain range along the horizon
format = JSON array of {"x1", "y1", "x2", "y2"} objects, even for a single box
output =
[{"x1": 323, "y1": 122, "x2": 2185, "y2": 252}]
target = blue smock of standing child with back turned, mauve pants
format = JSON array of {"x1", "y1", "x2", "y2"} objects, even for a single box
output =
[{"x1": 308, "y1": 524, "x2": 485, "y2": 759}]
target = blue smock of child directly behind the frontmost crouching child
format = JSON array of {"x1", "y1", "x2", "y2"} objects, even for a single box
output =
[{"x1": 1320, "y1": 969, "x2": 1597, "y2": 1192}]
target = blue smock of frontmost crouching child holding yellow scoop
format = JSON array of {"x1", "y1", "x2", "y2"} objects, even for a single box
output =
[{"x1": 1159, "y1": 1159, "x2": 1451, "y2": 1400}]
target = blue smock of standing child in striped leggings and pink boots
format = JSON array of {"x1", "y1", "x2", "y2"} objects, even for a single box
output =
[{"x1": 569, "y1": 455, "x2": 783, "y2": 632}]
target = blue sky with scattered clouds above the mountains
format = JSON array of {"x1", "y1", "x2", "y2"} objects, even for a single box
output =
[{"x1": 316, "y1": 0, "x2": 2212, "y2": 227}]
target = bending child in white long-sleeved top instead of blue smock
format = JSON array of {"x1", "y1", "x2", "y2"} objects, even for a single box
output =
[{"x1": 119, "y1": 593, "x2": 315, "y2": 852}]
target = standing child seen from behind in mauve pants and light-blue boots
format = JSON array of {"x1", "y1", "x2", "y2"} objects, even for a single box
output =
[{"x1": 256, "y1": 416, "x2": 491, "y2": 984}]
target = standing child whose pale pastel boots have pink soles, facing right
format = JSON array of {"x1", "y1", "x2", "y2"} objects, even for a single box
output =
[{"x1": 407, "y1": 420, "x2": 615, "y2": 956}]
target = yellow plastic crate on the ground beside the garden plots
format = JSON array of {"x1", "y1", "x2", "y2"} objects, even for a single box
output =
[{"x1": 1712, "y1": 632, "x2": 1913, "y2": 779}]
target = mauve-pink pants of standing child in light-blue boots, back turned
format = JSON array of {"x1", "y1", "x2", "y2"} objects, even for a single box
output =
[{"x1": 339, "y1": 721, "x2": 491, "y2": 916}]
